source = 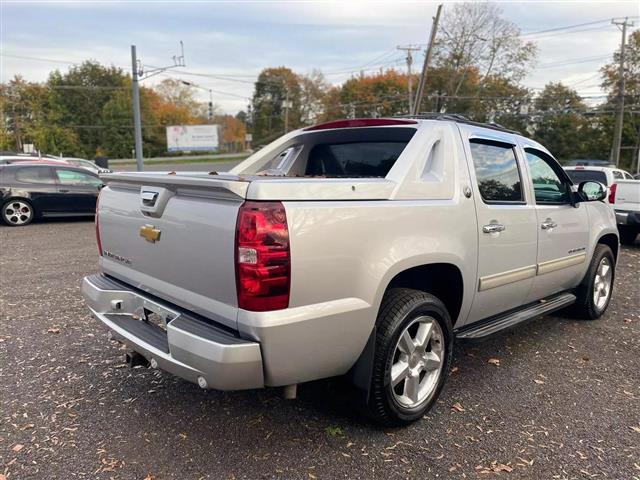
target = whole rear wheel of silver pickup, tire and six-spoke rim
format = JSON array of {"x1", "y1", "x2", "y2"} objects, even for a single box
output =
[{"x1": 368, "y1": 288, "x2": 453, "y2": 426}]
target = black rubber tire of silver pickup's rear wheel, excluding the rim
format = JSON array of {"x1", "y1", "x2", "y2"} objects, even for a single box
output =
[{"x1": 367, "y1": 288, "x2": 453, "y2": 427}]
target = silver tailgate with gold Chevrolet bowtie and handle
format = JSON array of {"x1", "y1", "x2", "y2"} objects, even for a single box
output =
[{"x1": 98, "y1": 174, "x2": 248, "y2": 329}]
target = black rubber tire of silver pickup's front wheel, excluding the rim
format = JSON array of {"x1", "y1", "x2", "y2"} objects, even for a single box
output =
[{"x1": 570, "y1": 243, "x2": 616, "y2": 320}]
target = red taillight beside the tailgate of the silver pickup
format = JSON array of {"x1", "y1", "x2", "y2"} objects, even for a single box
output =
[{"x1": 236, "y1": 202, "x2": 291, "y2": 312}]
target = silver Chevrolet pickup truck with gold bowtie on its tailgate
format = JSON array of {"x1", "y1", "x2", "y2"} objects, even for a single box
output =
[{"x1": 82, "y1": 116, "x2": 619, "y2": 425}]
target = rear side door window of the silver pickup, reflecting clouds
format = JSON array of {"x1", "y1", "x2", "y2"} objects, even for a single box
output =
[{"x1": 471, "y1": 140, "x2": 523, "y2": 202}]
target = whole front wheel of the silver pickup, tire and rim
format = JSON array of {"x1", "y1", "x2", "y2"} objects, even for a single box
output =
[{"x1": 572, "y1": 243, "x2": 616, "y2": 320}]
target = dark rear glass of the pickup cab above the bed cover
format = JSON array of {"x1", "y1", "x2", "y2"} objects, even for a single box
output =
[{"x1": 307, "y1": 142, "x2": 407, "y2": 177}]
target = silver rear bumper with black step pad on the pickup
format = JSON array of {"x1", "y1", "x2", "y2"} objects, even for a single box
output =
[{"x1": 82, "y1": 275, "x2": 264, "y2": 390}]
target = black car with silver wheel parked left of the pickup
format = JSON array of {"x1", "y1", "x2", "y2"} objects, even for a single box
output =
[{"x1": 0, "y1": 160, "x2": 102, "y2": 227}]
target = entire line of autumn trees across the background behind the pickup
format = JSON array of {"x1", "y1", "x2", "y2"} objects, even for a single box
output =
[{"x1": 0, "y1": 2, "x2": 640, "y2": 167}]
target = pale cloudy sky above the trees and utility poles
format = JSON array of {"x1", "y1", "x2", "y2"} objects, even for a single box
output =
[{"x1": 0, "y1": 0, "x2": 640, "y2": 113}]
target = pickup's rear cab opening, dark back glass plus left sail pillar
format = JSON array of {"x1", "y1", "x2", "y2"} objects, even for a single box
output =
[{"x1": 241, "y1": 127, "x2": 416, "y2": 178}]
